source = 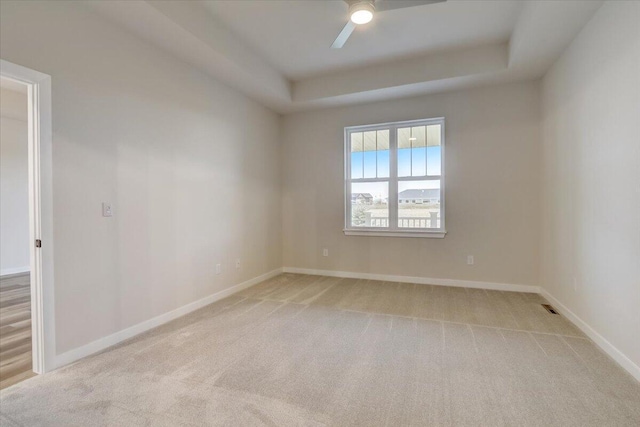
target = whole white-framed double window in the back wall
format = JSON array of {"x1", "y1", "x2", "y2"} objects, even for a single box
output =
[{"x1": 344, "y1": 118, "x2": 446, "y2": 238}]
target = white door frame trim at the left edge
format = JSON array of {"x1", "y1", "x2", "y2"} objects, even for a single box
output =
[{"x1": 0, "y1": 60, "x2": 56, "y2": 374}]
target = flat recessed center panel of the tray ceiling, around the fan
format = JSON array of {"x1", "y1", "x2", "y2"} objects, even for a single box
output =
[{"x1": 205, "y1": 0, "x2": 522, "y2": 80}]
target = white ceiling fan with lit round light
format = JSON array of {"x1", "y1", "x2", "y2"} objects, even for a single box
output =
[{"x1": 331, "y1": 0, "x2": 447, "y2": 49}]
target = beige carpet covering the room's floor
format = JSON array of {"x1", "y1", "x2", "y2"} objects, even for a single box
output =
[{"x1": 0, "y1": 274, "x2": 640, "y2": 426}]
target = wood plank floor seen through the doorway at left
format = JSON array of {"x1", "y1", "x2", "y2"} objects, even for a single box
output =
[{"x1": 0, "y1": 273, "x2": 35, "y2": 389}]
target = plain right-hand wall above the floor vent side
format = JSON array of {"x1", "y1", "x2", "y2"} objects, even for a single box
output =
[{"x1": 541, "y1": 2, "x2": 640, "y2": 375}]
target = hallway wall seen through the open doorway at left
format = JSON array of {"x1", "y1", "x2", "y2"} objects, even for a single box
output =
[{"x1": 0, "y1": 88, "x2": 29, "y2": 275}]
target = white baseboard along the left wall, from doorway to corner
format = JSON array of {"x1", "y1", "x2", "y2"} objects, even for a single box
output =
[{"x1": 54, "y1": 268, "x2": 282, "y2": 369}]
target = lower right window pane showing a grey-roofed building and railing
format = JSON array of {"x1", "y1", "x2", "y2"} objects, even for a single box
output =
[{"x1": 398, "y1": 180, "x2": 441, "y2": 229}]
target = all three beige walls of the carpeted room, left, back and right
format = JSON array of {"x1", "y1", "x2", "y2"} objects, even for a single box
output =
[{"x1": 0, "y1": 1, "x2": 640, "y2": 382}]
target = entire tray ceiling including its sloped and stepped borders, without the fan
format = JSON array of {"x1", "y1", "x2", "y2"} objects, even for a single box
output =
[{"x1": 86, "y1": 0, "x2": 602, "y2": 113}]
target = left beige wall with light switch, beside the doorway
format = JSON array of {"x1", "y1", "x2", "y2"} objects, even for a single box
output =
[{"x1": 0, "y1": 1, "x2": 282, "y2": 354}]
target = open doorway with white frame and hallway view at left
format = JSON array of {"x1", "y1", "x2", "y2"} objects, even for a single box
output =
[{"x1": 0, "y1": 60, "x2": 56, "y2": 388}]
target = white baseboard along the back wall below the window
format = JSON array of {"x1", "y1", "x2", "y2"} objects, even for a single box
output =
[{"x1": 282, "y1": 267, "x2": 540, "y2": 294}]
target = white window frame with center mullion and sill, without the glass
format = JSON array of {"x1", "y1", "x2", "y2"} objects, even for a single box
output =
[{"x1": 343, "y1": 117, "x2": 447, "y2": 239}]
